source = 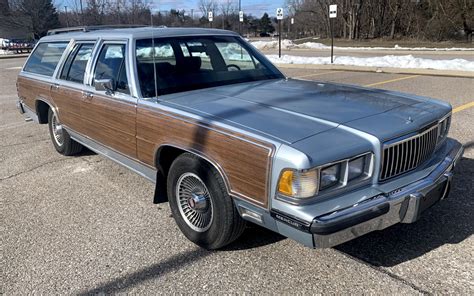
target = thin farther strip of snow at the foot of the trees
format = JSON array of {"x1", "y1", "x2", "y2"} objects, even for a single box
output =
[{"x1": 252, "y1": 39, "x2": 474, "y2": 51}]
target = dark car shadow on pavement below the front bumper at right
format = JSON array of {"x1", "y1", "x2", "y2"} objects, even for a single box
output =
[{"x1": 335, "y1": 156, "x2": 474, "y2": 267}]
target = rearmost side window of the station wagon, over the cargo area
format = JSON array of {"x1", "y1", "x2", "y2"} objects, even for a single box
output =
[{"x1": 23, "y1": 42, "x2": 68, "y2": 76}]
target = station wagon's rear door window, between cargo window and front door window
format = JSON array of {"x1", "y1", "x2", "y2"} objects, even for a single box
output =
[{"x1": 60, "y1": 43, "x2": 94, "y2": 83}]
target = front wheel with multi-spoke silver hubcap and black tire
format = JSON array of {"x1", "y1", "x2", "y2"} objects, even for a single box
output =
[{"x1": 167, "y1": 153, "x2": 245, "y2": 250}]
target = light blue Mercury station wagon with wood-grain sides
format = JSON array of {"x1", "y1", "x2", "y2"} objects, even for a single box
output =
[{"x1": 17, "y1": 28, "x2": 463, "y2": 249}]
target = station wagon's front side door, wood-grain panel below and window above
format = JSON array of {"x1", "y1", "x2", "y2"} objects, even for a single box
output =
[{"x1": 80, "y1": 41, "x2": 137, "y2": 158}]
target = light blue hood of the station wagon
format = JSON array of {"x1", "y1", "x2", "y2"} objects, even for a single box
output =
[{"x1": 161, "y1": 79, "x2": 450, "y2": 143}]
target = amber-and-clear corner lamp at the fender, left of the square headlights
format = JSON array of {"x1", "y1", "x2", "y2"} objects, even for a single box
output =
[{"x1": 278, "y1": 169, "x2": 319, "y2": 198}]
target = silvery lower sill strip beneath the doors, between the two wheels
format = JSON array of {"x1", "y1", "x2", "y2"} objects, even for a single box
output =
[{"x1": 63, "y1": 126, "x2": 156, "y2": 183}]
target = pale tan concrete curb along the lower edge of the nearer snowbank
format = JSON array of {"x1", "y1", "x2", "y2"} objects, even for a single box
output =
[{"x1": 276, "y1": 63, "x2": 474, "y2": 78}]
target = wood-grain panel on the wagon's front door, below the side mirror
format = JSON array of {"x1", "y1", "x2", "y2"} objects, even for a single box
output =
[{"x1": 81, "y1": 95, "x2": 137, "y2": 158}]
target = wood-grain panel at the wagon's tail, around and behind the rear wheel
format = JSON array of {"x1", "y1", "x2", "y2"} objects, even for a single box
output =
[{"x1": 17, "y1": 76, "x2": 51, "y2": 110}]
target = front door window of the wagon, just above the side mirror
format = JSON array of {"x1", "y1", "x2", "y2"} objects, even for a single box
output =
[{"x1": 93, "y1": 44, "x2": 130, "y2": 94}]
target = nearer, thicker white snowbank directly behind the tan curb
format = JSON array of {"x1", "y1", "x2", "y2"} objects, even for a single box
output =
[{"x1": 267, "y1": 55, "x2": 474, "y2": 71}]
